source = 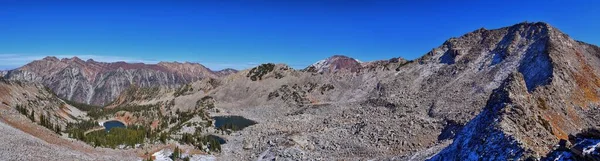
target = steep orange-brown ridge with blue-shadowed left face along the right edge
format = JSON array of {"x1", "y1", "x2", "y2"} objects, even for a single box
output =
[{"x1": 432, "y1": 23, "x2": 600, "y2": 160}]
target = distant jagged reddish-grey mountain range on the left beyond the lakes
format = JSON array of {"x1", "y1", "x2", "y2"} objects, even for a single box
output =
[{"x1": 5, "y1": 57, "x2": 235, "y2": 105}]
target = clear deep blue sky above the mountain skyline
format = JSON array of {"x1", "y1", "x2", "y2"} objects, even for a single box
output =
[{"x1": 0, "y1": 0, "x2": 600, "y2": 69}]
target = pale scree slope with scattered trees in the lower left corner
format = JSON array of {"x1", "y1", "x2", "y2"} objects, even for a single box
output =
[{"x1": 0, "y1": 78, "x2": 137, "y2": 160}]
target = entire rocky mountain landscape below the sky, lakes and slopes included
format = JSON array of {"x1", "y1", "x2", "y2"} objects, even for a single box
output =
[{"x1": 0, "y1": 22, "x2": 600, "y2": 161}]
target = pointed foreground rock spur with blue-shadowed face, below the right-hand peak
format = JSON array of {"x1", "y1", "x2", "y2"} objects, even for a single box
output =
[{"x1": 431, "y1": 74, "x2": 532, "y2": 160}]
